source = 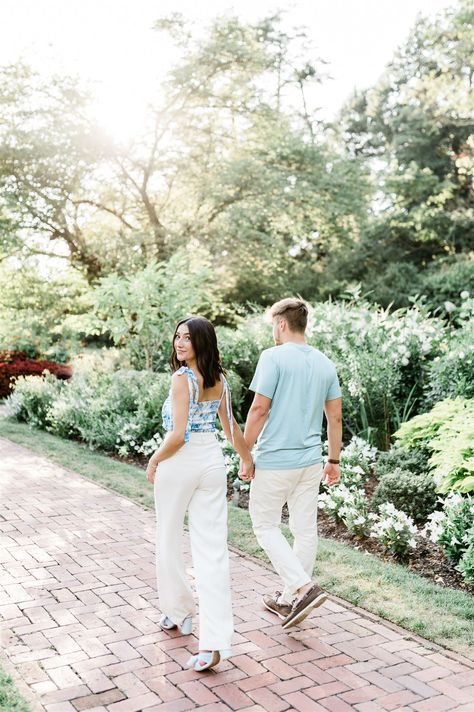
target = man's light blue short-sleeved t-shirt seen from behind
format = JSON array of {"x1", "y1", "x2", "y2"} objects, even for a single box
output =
[{"x1": 250, "y1": 342, "x2": 341, "y2": 470}]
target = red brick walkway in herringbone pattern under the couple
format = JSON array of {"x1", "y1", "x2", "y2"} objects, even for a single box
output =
[{"x1": 0, "y1": 439, "x2": 474, "y2": 712}]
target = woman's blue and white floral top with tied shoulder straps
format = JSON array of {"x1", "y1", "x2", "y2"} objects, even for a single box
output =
[{"x1": 162, "y1": 366, "x2": 234, "y2": 443}]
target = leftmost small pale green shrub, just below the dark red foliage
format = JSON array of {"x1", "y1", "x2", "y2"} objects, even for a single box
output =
[{"x1": 6, "y1": 374, "x2": 66, "y2": 428}]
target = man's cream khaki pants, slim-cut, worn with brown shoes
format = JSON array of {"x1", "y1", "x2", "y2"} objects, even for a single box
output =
[{"x1": 249, "y1": 463, "x2": 323, "y2": 603}]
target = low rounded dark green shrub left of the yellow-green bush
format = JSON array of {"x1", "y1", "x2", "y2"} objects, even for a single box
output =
[{"x1": 371, "y1": 468, "x2": 437, "y2": 524}]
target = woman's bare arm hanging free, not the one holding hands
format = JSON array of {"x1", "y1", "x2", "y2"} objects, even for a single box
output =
[{"x1": 146, "y1": 373, "x2": 189, "y2": 484}]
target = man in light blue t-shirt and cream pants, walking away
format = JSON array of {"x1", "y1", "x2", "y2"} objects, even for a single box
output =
[{"x1": 241, "y1": 299, "x2": 342, "y2": 629}]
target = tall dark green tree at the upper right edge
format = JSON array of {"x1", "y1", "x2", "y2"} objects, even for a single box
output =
[{"x1": 340, "y1": 0, "x2": 474, "y2": 306}]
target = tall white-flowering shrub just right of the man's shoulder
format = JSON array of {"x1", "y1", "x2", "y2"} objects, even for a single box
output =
[{"x1": 309, "y1": 300, "x2": 447, "y2": 446}]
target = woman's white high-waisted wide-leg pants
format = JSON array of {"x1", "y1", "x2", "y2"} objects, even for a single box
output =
[{"x1": 155, "y1": 433, "x2": 234, "y2": 653}]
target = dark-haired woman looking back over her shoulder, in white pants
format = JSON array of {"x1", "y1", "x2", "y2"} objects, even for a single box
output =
[{"x1": 147, "y1": 316, "x2": 253, "y2": 671}]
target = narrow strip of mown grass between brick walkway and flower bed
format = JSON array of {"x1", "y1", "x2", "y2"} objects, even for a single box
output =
[{"x1": 0, "y1": 419, "x2": 474, "y2": 658}]
